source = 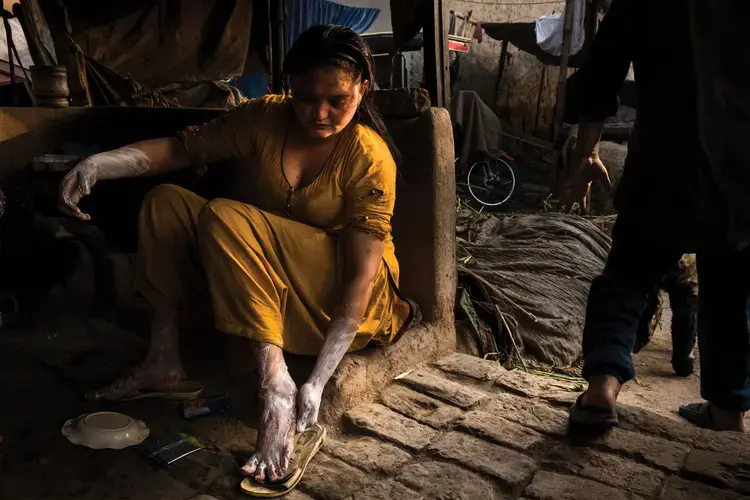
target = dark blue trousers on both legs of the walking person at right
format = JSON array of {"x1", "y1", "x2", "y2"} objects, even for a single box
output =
[{"x1": 583, "y1": 217, "x2": 750, "y2": 411}]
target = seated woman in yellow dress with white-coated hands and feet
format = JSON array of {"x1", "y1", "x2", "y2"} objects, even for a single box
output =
[{"x1": 60, "y1": 26, "x2": 414, "y2": 481}]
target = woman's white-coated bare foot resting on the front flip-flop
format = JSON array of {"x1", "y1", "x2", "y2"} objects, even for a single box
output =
[{"x1": 241, "y1": 370, "x2": 297, "y2": 482}]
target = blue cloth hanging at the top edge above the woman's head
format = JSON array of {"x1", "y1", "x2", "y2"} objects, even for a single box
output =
[{"x1": 285, "y1": 0, "x2": 380, "y2": 50}]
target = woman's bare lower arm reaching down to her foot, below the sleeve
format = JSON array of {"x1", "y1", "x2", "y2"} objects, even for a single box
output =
[{"x1": 297, "y1": 229, "x2": 384, "y2": 432}]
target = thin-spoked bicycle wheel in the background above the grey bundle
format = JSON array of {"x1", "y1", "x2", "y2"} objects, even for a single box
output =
[{"x1": 466, "y1": 158, "x2": 516, "y2": 207}]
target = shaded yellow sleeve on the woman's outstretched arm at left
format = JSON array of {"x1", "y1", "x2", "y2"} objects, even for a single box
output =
[{"x1": 177, "y1": 97, "x2": 268, "y2": 167}]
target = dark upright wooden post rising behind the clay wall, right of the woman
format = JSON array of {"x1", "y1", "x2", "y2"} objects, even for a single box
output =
[{"x1": 423, "y1": 0, "x2": 451, "y2": 109}]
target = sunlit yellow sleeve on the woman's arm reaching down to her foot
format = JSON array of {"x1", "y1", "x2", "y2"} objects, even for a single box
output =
[{"x1": 344, "y1": 132, "x2": 396, "y2": 240}]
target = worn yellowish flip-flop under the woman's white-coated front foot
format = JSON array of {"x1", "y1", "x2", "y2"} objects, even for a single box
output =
[{"x1": 240, "y1": 424, "x2": 326, "y2": 498}]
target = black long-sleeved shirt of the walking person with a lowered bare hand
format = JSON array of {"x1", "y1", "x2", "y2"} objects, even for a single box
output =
[{"x1": 577, "y1": 0, "x2": 721, "y2": 252}]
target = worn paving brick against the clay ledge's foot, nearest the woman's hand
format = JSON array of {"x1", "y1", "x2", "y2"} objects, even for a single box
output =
[{"x1": 346, "y1": 403, "x2": 438, "y2": 451}]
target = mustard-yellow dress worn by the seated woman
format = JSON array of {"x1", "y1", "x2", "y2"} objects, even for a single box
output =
[{"x1": 136, "y1": 96, "x2": 414, "y2": 355}]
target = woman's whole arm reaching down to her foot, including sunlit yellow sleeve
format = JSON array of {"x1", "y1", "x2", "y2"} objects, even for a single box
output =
[{"x1": 297, "y1": 141, "x2": 396, "y2": 431}]
